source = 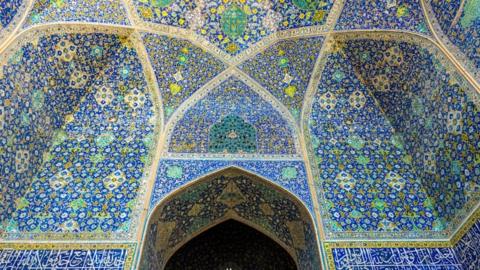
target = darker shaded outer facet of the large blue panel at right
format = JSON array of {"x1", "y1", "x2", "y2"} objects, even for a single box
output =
[{"x1": 345, "y1": 39, "x2": 480, "y2": 233}]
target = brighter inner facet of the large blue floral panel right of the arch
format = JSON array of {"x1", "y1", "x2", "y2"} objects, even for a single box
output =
[{"x1": 308, "y1": 49, "x2": 442, "y2": 238}]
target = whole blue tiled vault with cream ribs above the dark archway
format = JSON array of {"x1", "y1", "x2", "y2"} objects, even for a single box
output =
[{"x1": 0, "y1": 0, "x2": 480, "y2": 249}]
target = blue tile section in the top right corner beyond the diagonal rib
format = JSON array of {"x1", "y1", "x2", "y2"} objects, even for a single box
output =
[{"x1": 429, "y1": 0, "x2": 480, "y2": 71}]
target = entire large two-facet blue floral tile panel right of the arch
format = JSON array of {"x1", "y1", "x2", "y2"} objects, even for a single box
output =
[{"x1": 308, "y1": 34, "x2": 480, "y2": 239}]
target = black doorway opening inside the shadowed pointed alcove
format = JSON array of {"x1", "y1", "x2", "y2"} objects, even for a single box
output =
[{"x1": 165, "y1": 220, "x2": 297, "y2": 270}]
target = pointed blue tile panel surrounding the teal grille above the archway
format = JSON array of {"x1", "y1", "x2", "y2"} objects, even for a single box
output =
[{"x1": 162, "y1": 73, "x2": 299, "y2": 158}]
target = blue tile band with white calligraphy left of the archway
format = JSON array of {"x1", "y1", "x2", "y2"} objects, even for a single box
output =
[{"x1": 0, "y1": 249, "x2": 127, "y2": 270}]
